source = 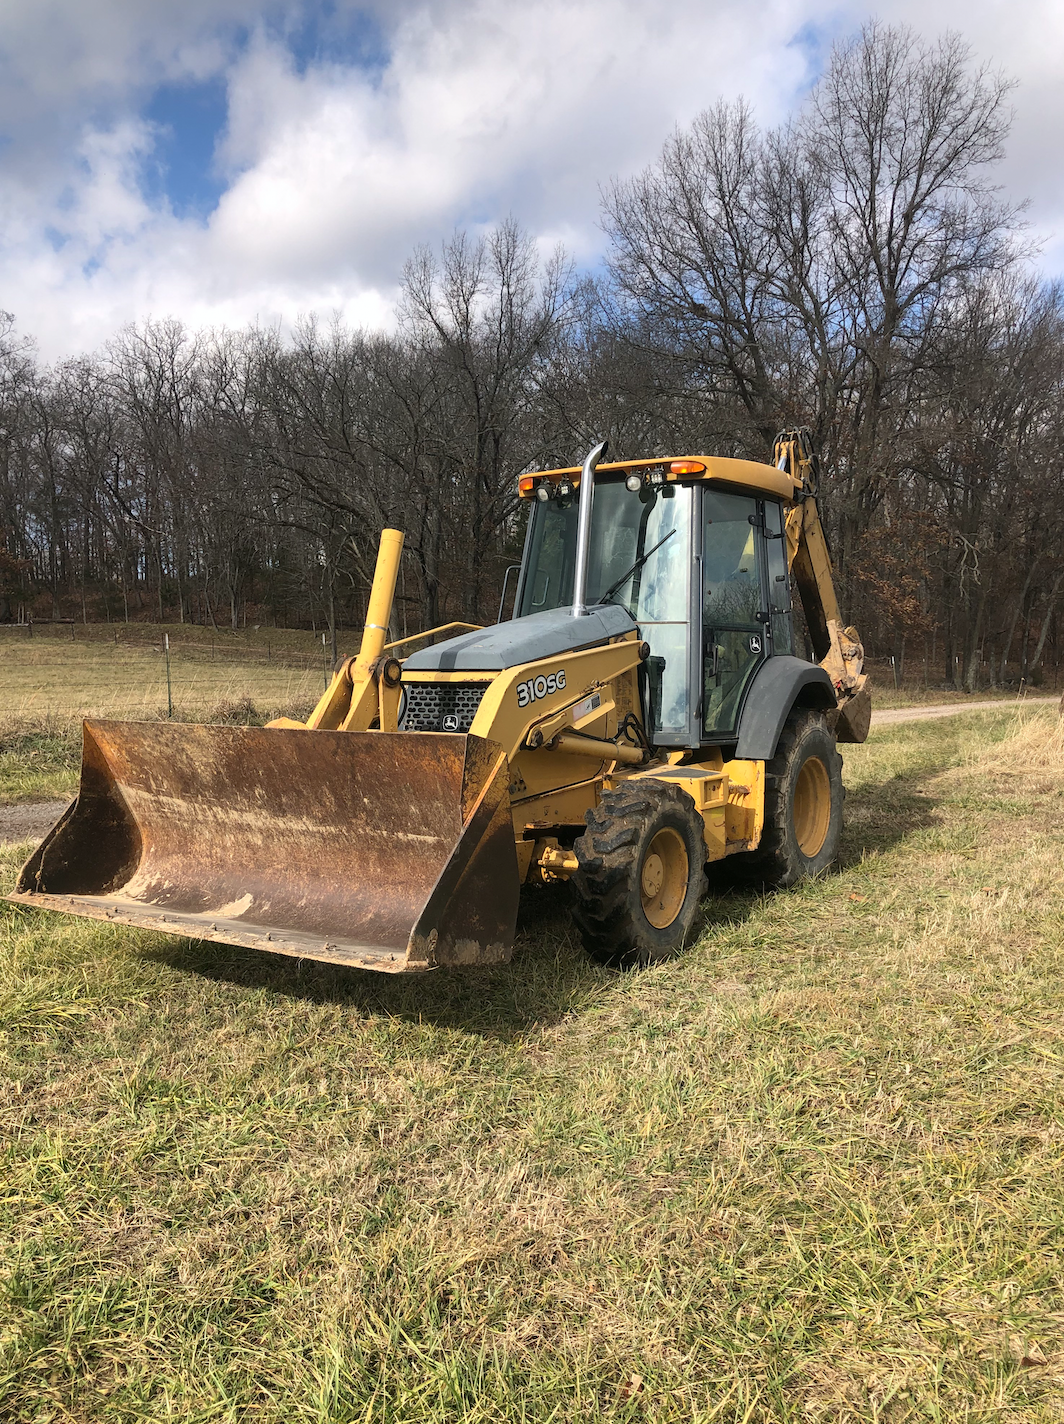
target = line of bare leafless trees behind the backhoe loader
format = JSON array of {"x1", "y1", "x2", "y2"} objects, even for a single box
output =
[{"x1": 0, "y1": 24, "x2": 1064, "y2": 689}]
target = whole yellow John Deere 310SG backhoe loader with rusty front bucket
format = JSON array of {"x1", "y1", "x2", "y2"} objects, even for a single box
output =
[{"x1": 10, "y1": 430, "x2": 870, "y2": 973}]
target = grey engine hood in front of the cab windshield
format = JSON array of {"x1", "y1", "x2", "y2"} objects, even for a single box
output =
[{"x1": 403, "y1": 604, "x2": 637, "y2": 672}]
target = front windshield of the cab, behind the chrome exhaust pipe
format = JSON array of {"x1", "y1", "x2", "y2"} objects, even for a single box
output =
[{"x1": 517, "y1": 481, "x2": 692, "y2": 740}]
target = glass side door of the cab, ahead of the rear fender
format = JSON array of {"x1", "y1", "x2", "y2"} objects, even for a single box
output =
[{"x1": 701, "y1": 488, "x2": 772, "y2": 742}]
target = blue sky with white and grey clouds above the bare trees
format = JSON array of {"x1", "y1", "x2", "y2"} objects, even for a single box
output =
[{"x1": 0, "y1": 0, "x2": 1064, "y2": 359}]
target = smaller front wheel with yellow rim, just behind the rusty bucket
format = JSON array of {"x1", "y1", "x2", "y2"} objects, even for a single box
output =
[{"x1": 570, "y1": 778, "x2": 705, "y2": 968}]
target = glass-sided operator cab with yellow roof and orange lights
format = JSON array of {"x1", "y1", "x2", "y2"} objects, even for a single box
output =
[{"x1": 514, "y1": 457, "x2": 795, "y2": 748}]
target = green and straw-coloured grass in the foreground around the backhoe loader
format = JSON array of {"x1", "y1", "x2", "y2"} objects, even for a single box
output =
[{"x1": 0, "y1": 709, "x2": 1064, "y2": 1424}]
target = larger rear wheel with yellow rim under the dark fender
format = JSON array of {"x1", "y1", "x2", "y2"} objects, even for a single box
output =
[{"x1": 742, "y1": 708, "x2": 846, "y2": 890}]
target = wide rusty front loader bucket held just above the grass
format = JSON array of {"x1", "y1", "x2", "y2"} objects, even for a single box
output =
[{"x1": 10, "y1": 722, "x2": 518, "y2": 973}]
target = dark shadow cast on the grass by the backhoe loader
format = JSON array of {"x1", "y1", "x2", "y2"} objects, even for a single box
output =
[{"x1": 137, "y1": 776, "x2": 936, "y2": 1038}]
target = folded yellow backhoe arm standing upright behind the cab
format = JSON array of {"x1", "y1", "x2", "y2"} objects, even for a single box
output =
[{"x1": 772, "y1": 429, "x2": 872, "y2": 742}]
